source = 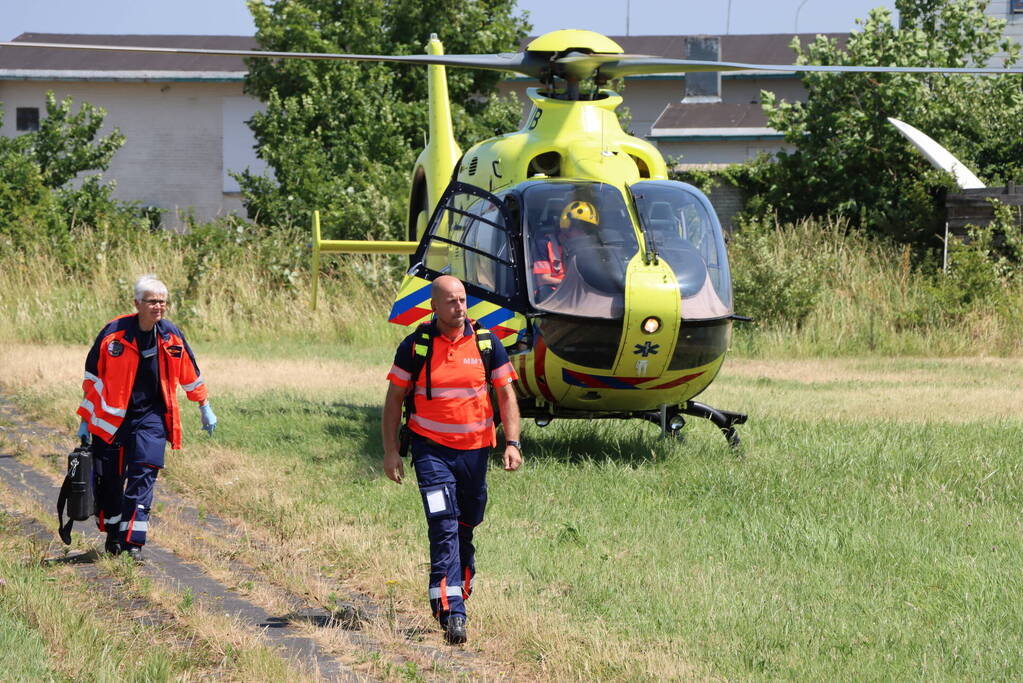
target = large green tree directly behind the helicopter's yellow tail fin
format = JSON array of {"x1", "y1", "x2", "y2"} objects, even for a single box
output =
[{"x1": 238, "y1": 0, "x2": 527, "y2": 238}]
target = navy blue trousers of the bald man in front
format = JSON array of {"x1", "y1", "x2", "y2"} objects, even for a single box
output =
[{"x1": 411, "y1": 436, "x2": 490, "y2": 625}]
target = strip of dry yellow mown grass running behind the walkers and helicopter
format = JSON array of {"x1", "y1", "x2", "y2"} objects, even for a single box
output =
[{"x1": 6, "y1": 344, "x2": 1023, "y2": 427}]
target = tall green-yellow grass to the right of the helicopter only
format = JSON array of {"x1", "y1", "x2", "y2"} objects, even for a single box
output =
[{"x1": 729, "y1": 220, "x2": 1023, "y2": 357}]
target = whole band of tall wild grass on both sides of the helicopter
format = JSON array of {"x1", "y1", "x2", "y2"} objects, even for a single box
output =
[{"x1": 0, "y1": 214, "x2": 1023, "y2": 360}]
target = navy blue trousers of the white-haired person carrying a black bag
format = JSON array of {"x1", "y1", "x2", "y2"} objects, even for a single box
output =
[{"x1": 92, "y1": 412, "x2": 167, "y2": 546}]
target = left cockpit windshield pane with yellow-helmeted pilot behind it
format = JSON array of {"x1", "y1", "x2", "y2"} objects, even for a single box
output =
[{"x1": 522, "y1": 182, "x2": 639, "y2": 319}]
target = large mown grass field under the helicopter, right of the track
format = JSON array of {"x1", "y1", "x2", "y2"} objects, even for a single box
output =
[{"x1": 0, "y1": 345, "x2": 1023, "y2": 680}]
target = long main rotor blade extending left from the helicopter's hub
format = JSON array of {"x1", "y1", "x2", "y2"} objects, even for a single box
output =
[{"x1": 0, "y1": 42, "x2": 550, "y2": 78}]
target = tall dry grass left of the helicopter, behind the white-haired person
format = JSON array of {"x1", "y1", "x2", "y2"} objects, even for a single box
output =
[{"x1": 0, "y1": 218, "x2": 397, "y2": 355}]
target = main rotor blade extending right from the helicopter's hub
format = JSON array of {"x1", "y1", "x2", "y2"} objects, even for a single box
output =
[{"x1": 597, "y1": 55, "x2": 1023, "y2": 79}]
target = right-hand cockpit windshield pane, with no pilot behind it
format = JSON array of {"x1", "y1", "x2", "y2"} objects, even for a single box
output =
[{"x1": 629, "y1": 180, "x2": 731, "y2": 320}]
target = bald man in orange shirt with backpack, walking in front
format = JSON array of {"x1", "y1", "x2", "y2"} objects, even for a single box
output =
[{"x1": 382, "y1": 275, "x2": 522, "y2": 644}]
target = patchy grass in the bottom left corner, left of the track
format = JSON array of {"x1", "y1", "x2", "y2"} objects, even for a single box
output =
[{"x1": 0, "y1": 496, "x2": 309, "y2": 683}]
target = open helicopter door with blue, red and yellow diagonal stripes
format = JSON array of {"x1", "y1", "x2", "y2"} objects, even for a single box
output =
[{"x1": 390, "y1": 182, "x2": 527, "y2": 346}]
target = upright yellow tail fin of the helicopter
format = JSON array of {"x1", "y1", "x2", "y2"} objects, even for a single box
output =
[{"x1": 408, "y1": 34, "x2": 461, "y2": 240}]
